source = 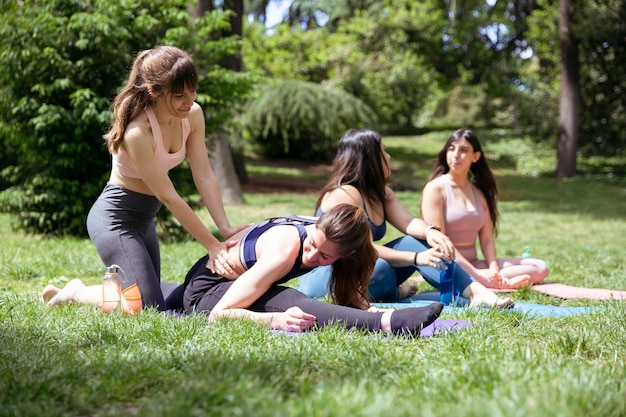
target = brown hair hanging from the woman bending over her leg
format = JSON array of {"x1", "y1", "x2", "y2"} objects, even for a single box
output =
[{"x1": 317, "y1": 204, "x2": 378, "y2": 307}]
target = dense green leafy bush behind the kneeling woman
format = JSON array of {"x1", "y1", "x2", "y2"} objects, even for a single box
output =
[{"x1": 0, "y1": 0, "x2": 252, "y2": 235}]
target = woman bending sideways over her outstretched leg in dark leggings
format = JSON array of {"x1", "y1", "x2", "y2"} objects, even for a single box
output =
[{"x1": 41, "y1": 204, "x2": 443, "y2": 336}]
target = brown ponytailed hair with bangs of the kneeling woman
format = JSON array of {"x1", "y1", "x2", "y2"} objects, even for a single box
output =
[{"x1": 104, "y1": 46, "x2": 198, "y2": 154}]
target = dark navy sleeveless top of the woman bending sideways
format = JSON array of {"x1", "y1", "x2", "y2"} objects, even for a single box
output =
[{"x1": 239, "y1": 216, "x2": 317, "y2": 284}]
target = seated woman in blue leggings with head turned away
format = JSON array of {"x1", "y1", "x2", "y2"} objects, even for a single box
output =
[{"x1": 300, "y1": 129, "x2": 513, "y2": 308}]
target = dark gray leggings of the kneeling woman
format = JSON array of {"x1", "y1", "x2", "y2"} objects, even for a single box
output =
[{"x1": 87, "y1": 184, "x2": 166, "y2": 310}]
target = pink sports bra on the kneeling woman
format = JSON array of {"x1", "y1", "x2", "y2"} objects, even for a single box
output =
[{"x1": 112, "y1": 107, "x2": 191, "y2": 178}]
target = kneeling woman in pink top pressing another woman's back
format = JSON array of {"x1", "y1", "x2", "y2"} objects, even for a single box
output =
[{"x1": 42, "y1": 46, "x2": 247, "y2": 313}]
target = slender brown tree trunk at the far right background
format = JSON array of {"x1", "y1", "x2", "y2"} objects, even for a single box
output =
[{"x1": 556, "y1": 0, "x2": 580, "y2": 178}]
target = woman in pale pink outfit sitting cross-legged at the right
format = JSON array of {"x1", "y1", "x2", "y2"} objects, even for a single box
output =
[{"x1": 422, "y1": 129, "x2": 548, "y2": 289}]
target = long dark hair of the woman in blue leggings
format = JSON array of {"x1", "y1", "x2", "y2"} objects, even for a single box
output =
[{"x1": 315, "y1": 129, "x2": 386, "y2": 211}]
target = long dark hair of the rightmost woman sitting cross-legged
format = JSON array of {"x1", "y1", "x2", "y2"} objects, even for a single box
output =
[{"x1": 430, "y1": 129, "x2": 498, "y2": 235}]
